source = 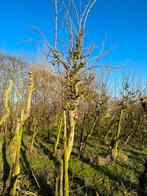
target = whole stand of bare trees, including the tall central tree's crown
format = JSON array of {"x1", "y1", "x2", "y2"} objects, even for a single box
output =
[{"x1": 0, "y1": 0, "x2": 145, "y2": 196}]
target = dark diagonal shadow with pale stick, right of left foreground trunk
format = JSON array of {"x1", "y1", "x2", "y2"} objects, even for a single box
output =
[{"x1": 21, "y1": 141, "x2": 53, "y2": 196}]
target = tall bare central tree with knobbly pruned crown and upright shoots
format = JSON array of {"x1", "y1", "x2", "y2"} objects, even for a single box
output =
[{"x1": 37, "y1": 0, "x2": 99, "y2": 196}]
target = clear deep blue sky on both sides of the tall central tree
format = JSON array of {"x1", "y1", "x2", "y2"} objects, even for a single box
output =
[{"x1": 0, "y1": 0, "x2": 147, "y2": 82}]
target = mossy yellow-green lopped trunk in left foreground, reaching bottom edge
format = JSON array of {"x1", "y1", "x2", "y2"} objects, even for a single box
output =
[{"x1": 2, "y1": 72, "x2": 34, "y2": 196}]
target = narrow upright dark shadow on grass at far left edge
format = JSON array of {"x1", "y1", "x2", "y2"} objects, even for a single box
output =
[{"x1": 2, "y1": 137, "x2": 10, "y2": 187}]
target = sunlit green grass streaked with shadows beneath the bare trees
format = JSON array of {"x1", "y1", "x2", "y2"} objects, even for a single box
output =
[{"x1": 0, "y1": 128, "x2": 147, "y2": 196}]
